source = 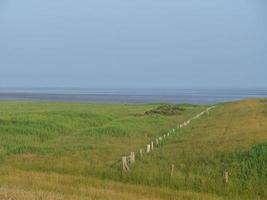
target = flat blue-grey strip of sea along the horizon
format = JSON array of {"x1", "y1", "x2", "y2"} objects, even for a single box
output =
[{"x1": 0, "y1": 89, "x2": 267, "y2": 104}]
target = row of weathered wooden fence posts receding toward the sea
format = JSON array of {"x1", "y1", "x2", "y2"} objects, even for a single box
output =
[{"x1": 122, "y1": 106, "x2": 215, "y2": 171}]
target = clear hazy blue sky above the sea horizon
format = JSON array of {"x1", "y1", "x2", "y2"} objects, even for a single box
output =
[{"x1": 0, "y1": 0, "x2": 267, "y2": 89}]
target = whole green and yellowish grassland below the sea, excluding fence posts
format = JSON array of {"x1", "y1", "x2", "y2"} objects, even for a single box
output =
[{"x1": 0, "y1": 99, "x2": 267, "y2": 200}]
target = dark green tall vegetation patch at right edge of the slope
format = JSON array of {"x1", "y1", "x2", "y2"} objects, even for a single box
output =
[{"x1": 215, "y1": 143, "x2": 267, "y2": 198}]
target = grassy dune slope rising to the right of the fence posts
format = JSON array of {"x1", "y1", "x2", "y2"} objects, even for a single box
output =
[{"x1": 125, "y1": 100, "x2": 267, "y2": 199}]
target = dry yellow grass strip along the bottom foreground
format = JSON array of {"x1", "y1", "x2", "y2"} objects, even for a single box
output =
[{"x1": 0, "y1": 171, "x2": 221, "y2": 200}]
